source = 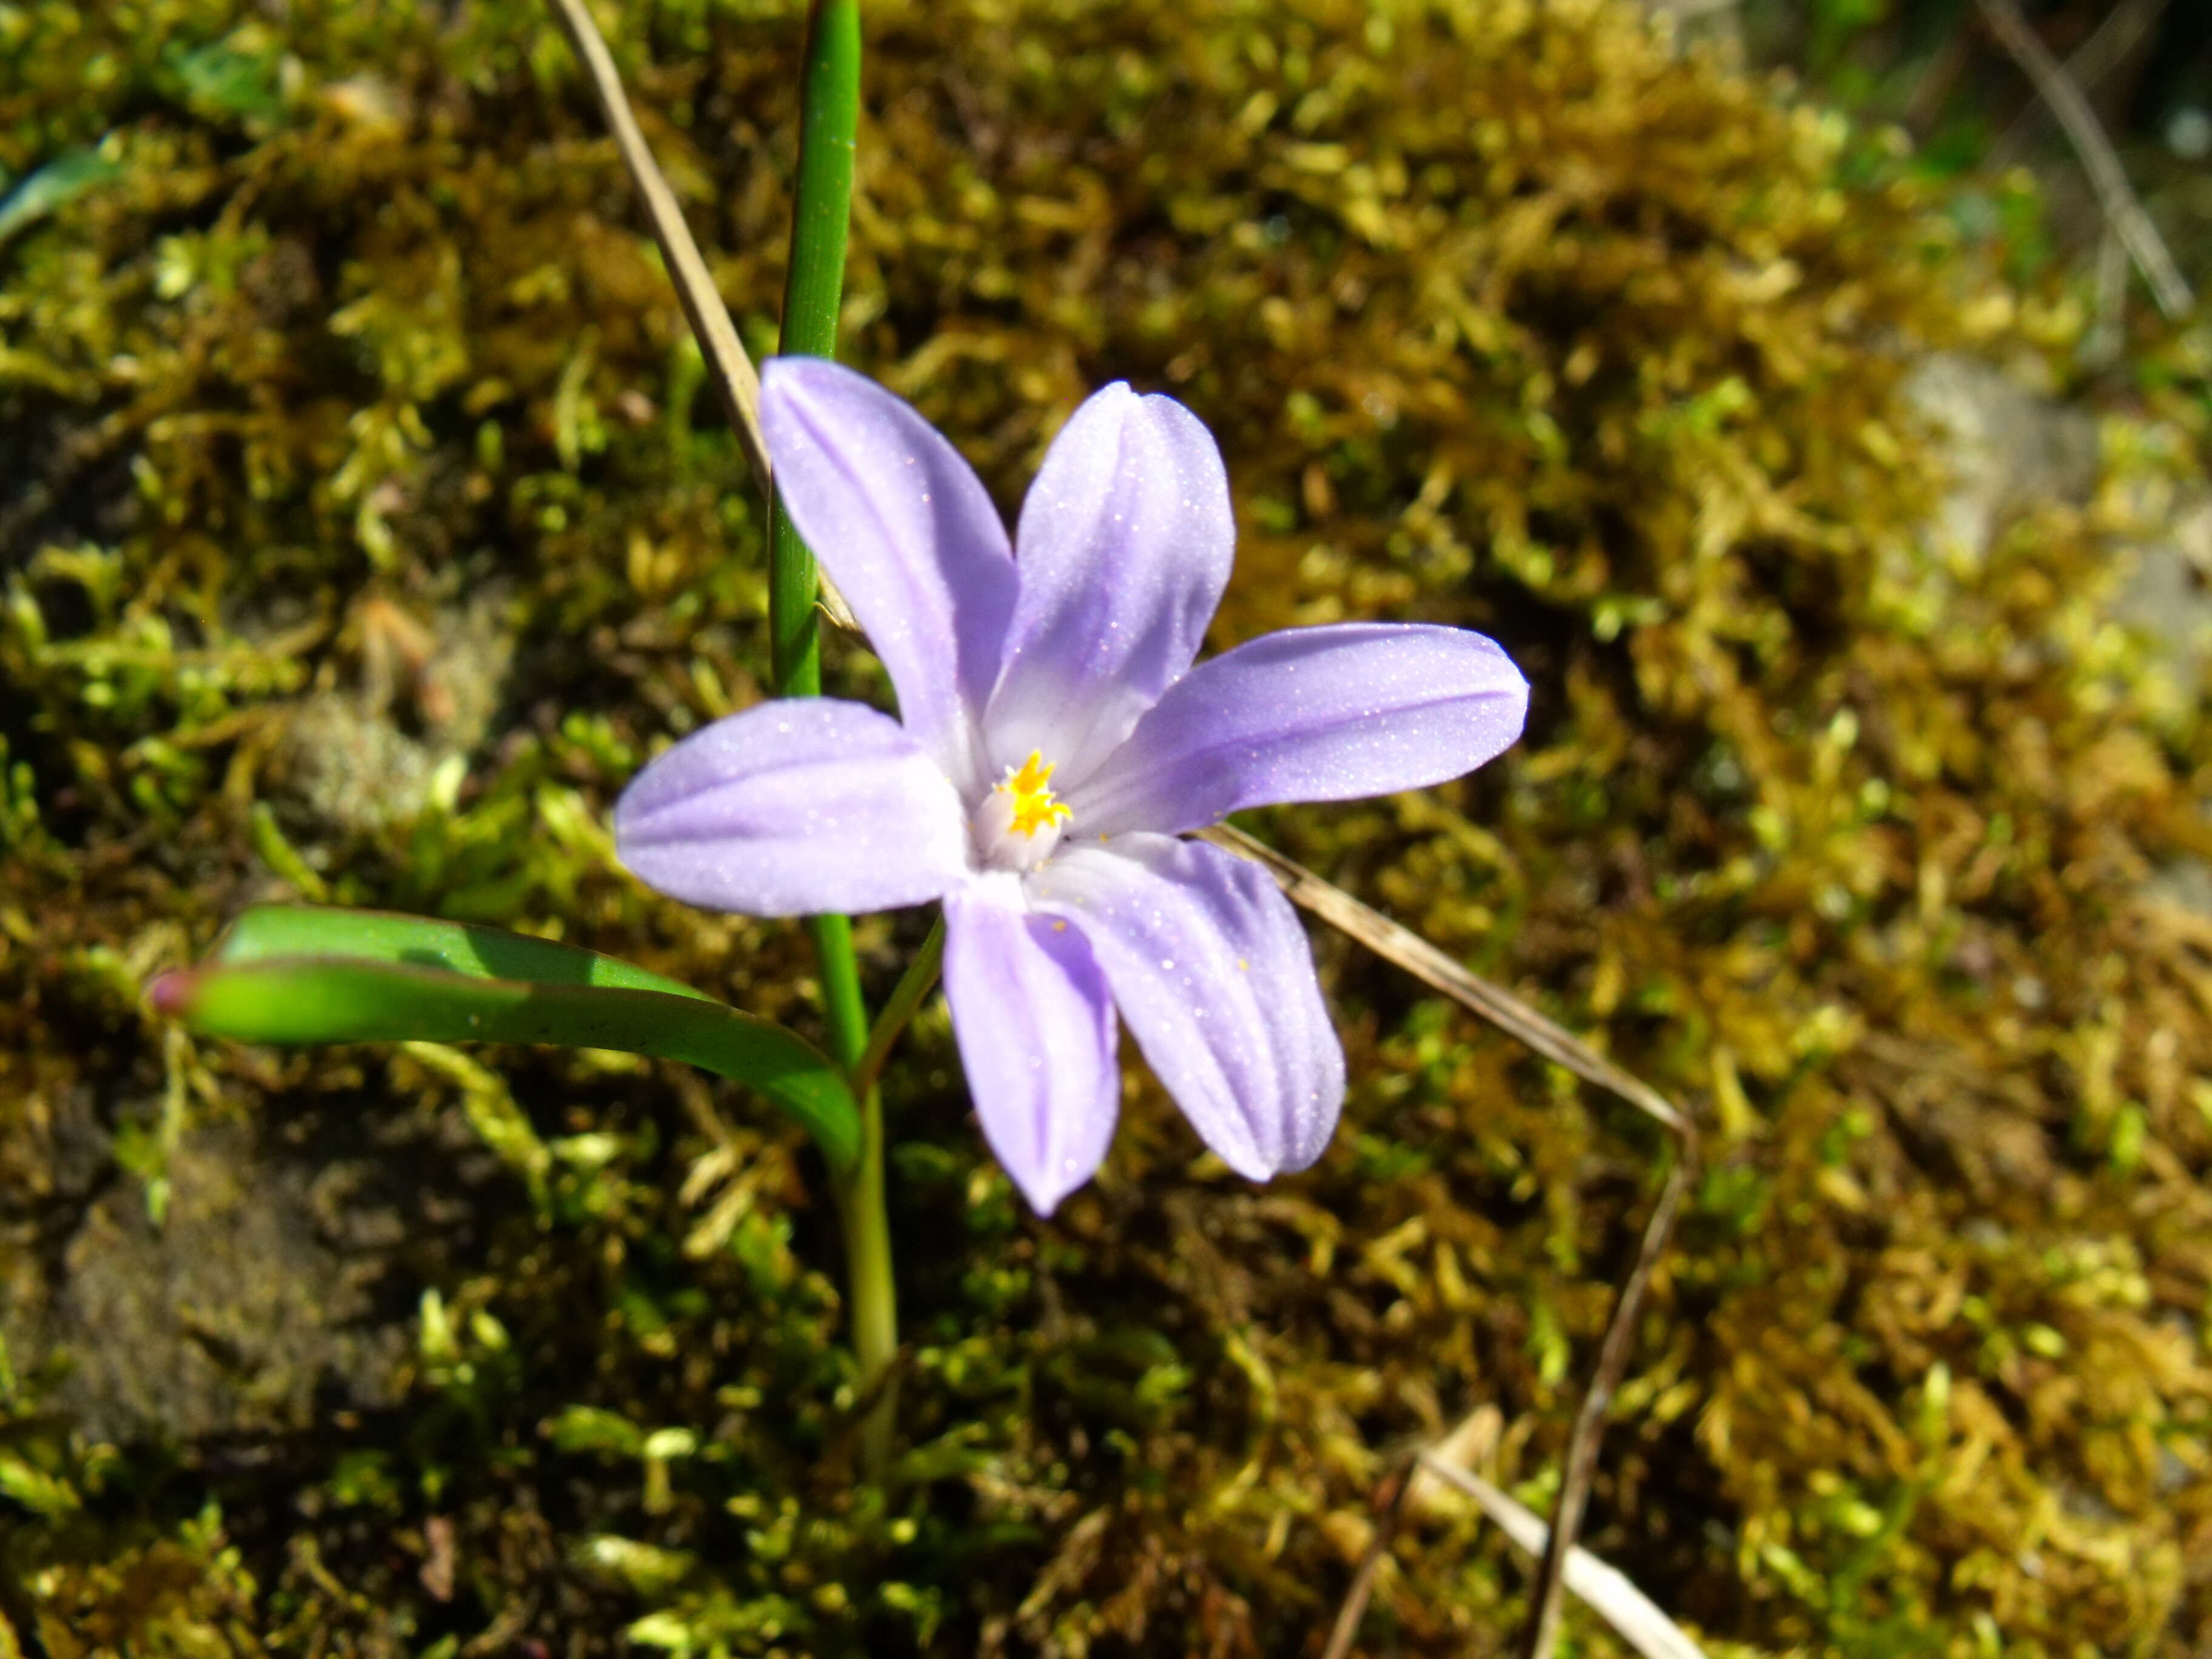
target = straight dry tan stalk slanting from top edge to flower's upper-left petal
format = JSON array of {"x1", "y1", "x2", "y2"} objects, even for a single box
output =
[{"x1": 549, "y1": 0, "x2": 858, "y2": 632}]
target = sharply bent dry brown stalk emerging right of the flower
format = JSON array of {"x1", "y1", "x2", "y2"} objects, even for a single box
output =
[{"x1": 1201, "y1": 823, "x2": 1697, "y2": 1659}]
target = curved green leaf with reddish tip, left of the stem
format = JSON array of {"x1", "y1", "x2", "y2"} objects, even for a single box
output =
[{"x1": 150, "y1": 905, "x2": 860, "y2": 1179}]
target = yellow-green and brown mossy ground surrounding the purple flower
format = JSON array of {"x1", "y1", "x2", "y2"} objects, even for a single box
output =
[{"x1": 0, "y1": 0, "x2": 2212, "y2": 1659}]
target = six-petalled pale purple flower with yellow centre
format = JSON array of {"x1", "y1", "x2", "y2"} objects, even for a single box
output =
[{"x1": 615, "y1": 358, "x2": 1529, "y2": 1212}]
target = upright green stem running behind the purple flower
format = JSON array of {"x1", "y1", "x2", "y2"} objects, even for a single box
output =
[{"x1": 768, "y1": 0, "x2": 898, "y2": 1478}]
